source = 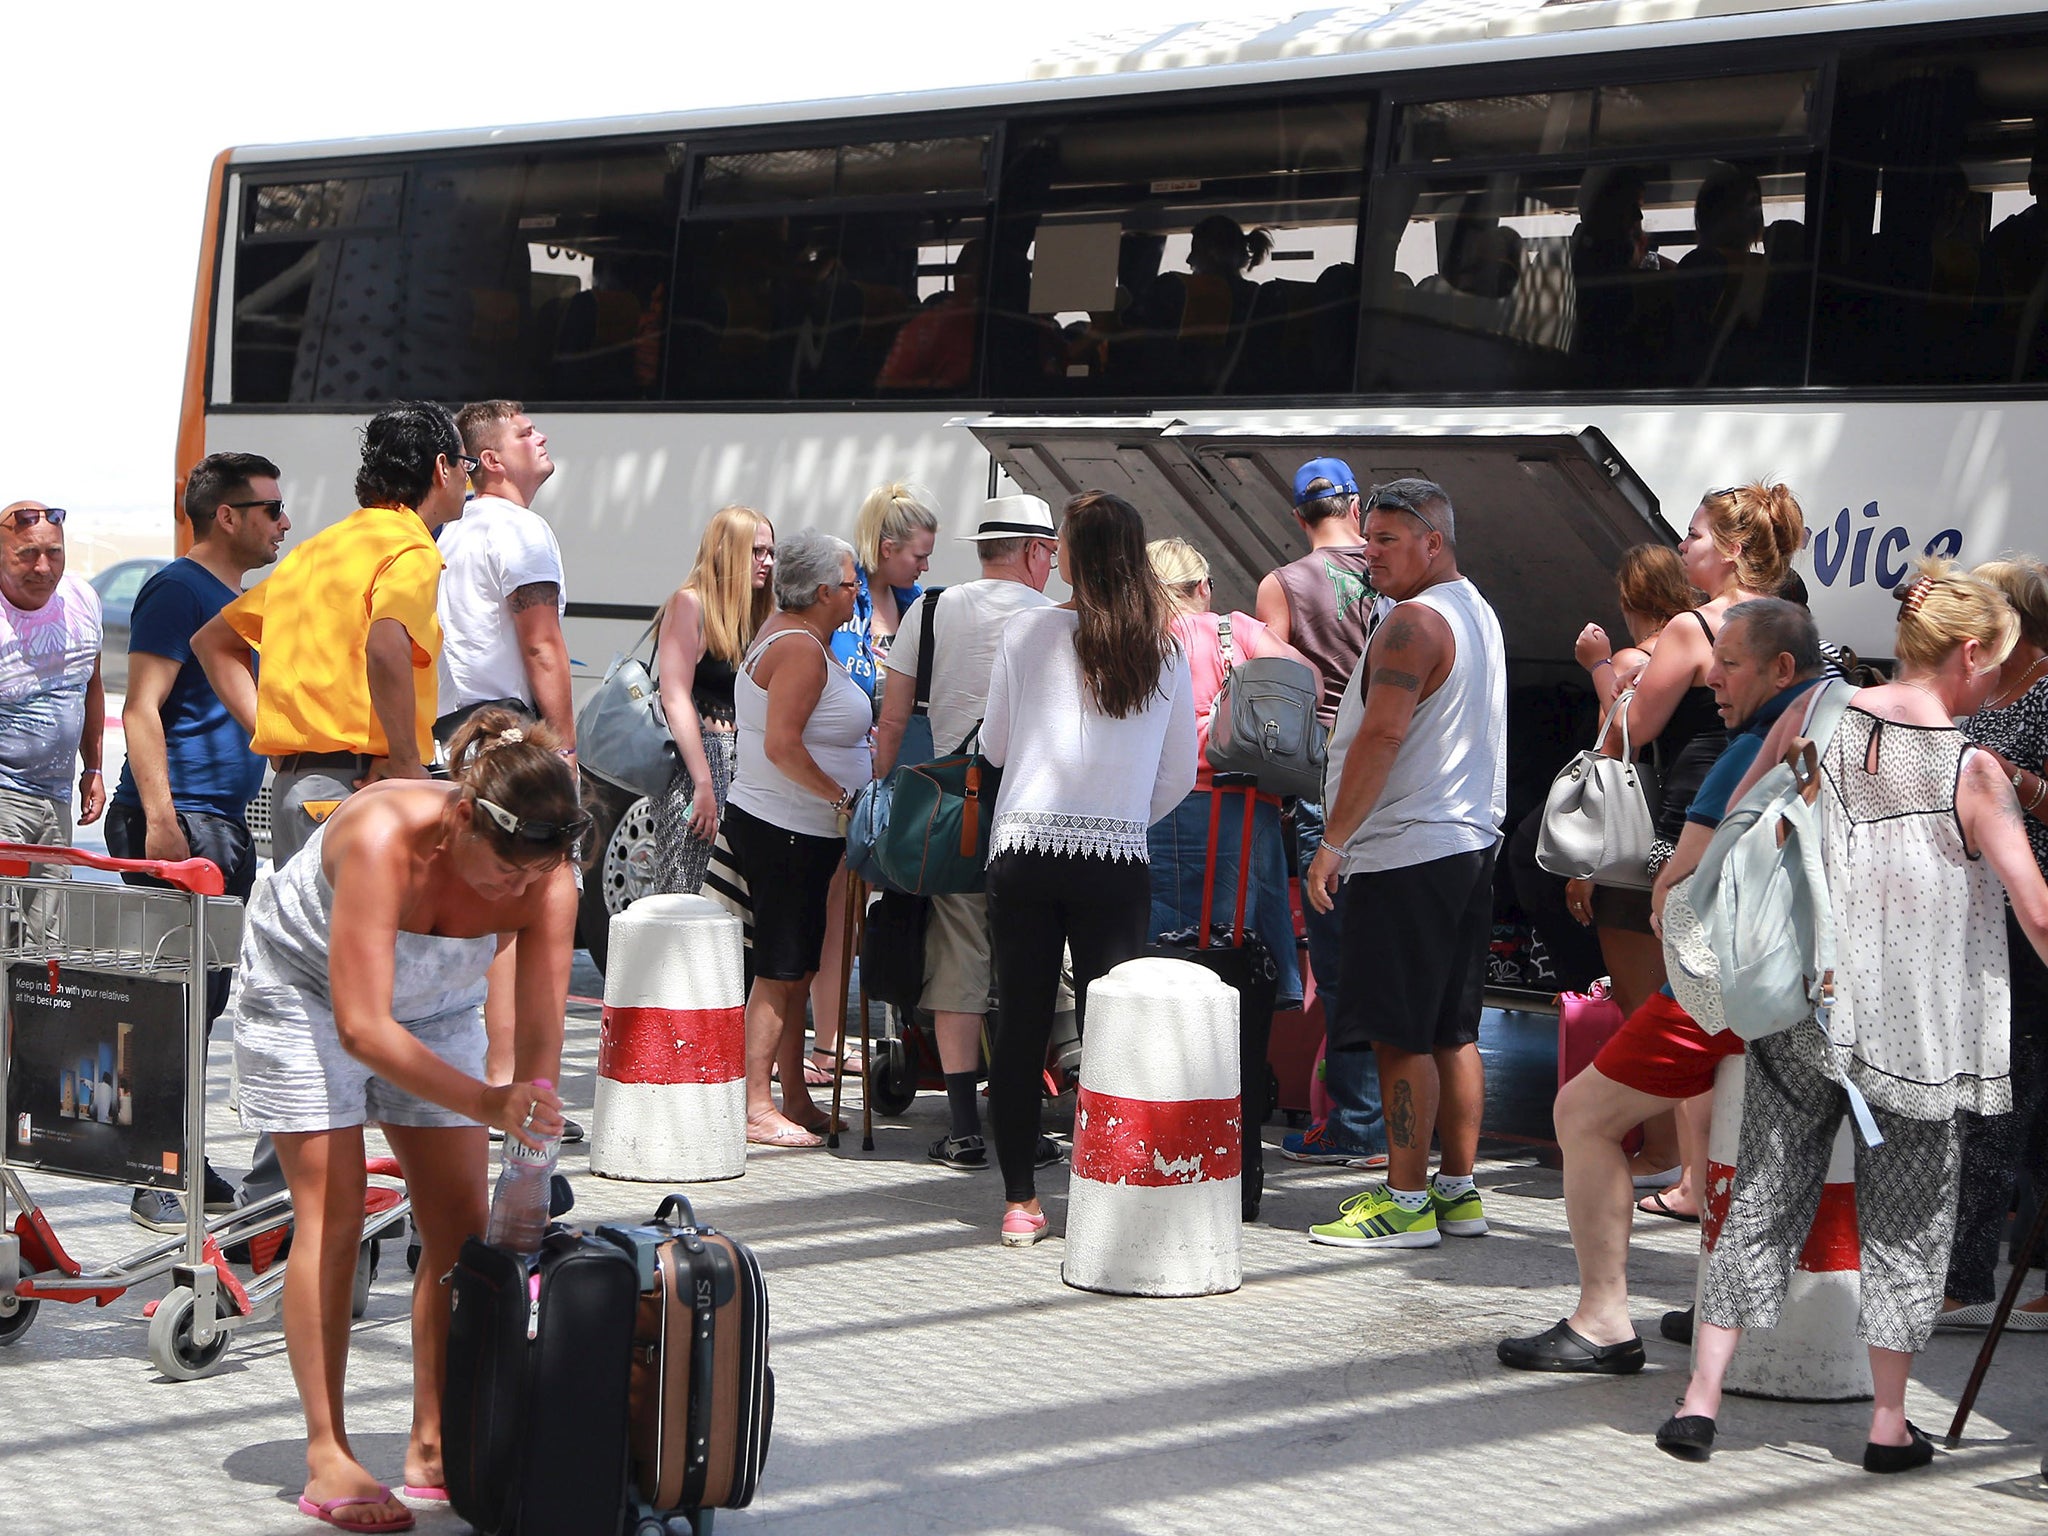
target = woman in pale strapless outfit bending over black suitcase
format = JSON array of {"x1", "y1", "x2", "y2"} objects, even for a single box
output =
[{"x1": 227, "y1": 709, "x2": 590, "y2": 1530}]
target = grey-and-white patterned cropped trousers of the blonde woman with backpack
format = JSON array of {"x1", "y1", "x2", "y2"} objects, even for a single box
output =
[{"x1": 1700, "y1": 1020, "x2": 1962, "y2": 1354}]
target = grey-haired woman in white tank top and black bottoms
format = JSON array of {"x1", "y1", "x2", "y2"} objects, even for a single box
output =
[{"x1": 725, "y1": 528, "x2": 874, "y2": 1147}]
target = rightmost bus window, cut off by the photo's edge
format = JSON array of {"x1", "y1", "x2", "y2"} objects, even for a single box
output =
[{"x1": 1815, "y1": 37, "x2": 2048, "y2": 385}]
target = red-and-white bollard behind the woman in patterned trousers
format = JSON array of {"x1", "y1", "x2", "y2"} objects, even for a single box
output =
[{"x1": 1694, "y1": 1057, "x2": 1870, "y2": 1403}]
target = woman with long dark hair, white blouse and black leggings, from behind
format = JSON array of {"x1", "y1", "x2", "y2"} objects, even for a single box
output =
[{"x1": 981, "y1": 492, "x2": 1194, "y2": 1247}]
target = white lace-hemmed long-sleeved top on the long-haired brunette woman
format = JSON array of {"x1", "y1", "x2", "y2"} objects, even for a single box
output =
[{"x1": 981, "y1": 608, "x2": 1196, "y2": 864}]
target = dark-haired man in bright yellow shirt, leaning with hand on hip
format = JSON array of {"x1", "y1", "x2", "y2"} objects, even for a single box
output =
[{"x1": 193, "y1": 403, "x2": 477, "y2": 864}]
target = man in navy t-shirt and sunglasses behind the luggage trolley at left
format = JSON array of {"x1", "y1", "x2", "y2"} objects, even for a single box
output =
[{"x1": 106, "y1": 453, "x2": 291, "y2": 1231}]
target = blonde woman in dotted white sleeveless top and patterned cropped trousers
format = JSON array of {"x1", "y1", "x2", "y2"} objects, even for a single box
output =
[{"x1": 1657, "y1": 561, "x2": 2048, "y2": 1473}]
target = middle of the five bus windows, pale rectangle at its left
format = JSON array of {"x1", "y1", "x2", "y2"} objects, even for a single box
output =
[{"x1": 989, "y1": 100, "x2": 1370, "y2": 399}]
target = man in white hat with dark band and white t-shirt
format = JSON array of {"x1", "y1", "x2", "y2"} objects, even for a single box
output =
[{"x1": 874, "y1": 496, "x2": 1059, "y2": 1167}]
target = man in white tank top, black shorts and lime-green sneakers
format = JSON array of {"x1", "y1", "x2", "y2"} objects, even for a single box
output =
[{"x1": 1307, "y1": 479, "x2": 1507, "y2": 1247}]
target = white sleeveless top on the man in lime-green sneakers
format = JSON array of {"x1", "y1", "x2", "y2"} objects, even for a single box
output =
[{"x1": 1325, "y1": 575, "x2": 1507, "y2": 874}]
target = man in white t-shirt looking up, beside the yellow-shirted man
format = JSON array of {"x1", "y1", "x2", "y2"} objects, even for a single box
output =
[{"x1": 434, "y1": 399, "x2": 584, "y2": 1141}]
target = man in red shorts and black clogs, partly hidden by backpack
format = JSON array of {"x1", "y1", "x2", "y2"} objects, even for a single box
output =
[{"x1": 1499, "y1": 598, "x2": 1823, "y2": 1376}]
